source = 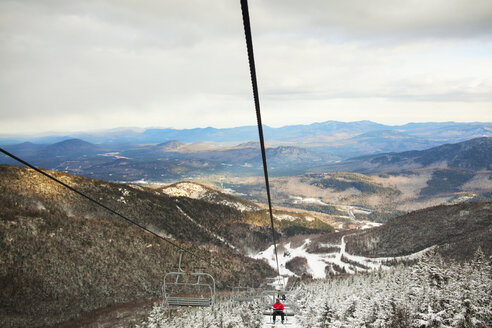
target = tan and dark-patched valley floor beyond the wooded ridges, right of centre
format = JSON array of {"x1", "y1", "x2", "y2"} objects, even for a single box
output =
[{"x1": 197, "y1": 168, "x2": 492, "y2": 223}]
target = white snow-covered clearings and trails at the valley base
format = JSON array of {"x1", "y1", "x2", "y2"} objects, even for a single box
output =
[{"x1": 254, "y1": 236, "x2": 434, "y2": 279}]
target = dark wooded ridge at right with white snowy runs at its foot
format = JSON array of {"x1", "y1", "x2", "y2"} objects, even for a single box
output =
[{"x1": 254, "y1": 202, "x2": 492, "y2": 278}]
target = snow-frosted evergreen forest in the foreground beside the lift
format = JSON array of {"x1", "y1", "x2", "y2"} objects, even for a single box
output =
[{"x1": 138, "y1": 249, "x2": 492, "y2": 328}]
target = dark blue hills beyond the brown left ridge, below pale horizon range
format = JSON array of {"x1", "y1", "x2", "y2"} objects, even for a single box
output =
[{"x1": 0, "y1": 139, "x2": 332, "y2": 181}]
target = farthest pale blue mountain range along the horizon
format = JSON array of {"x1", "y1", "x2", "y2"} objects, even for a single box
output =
[{"x1": 0, "y1": 121, "x2": 492, "y2": 159}]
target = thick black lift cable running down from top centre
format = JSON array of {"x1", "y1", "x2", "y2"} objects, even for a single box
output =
[{"x1": 241, "y1": 0, "x2": 280, "y2": 276}]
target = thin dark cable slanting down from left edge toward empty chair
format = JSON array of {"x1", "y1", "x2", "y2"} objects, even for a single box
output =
[{"x1": 0, "y1": 148, "x2": 224, "y2": 270}]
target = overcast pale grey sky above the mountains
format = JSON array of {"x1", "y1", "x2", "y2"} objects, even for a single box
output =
[{"x1": 0, "y1": 0, "x2": 492, "y2": 134}]
